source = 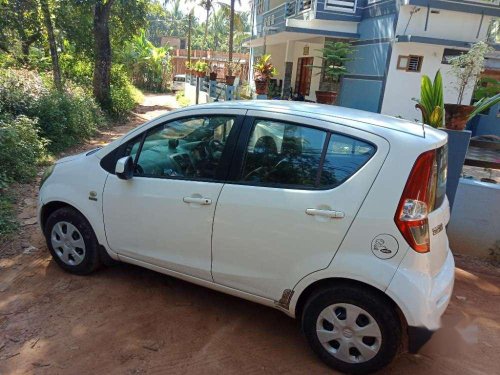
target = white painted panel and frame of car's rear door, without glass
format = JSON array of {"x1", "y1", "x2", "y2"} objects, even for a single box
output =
[{"x1": 212, "y1": 111, "x2": 389, "y2": 301}]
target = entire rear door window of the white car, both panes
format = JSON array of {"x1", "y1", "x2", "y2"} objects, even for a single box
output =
[{"x1": 240, "y1": 119, "x2": 376, "y2": 189}]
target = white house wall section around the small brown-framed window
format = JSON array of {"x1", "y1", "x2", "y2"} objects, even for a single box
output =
[{"x1": 382, "y1": 43, "x2": 473, "y2": 121}]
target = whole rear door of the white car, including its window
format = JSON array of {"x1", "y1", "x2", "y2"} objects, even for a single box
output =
[{"x1": 212, "y1": 111, "x2": 389, "y2": 301}]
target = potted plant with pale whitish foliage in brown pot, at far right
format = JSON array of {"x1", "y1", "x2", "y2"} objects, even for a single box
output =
[{"x1": 444, "y1": 42, "x2": 493, "y2": 130}]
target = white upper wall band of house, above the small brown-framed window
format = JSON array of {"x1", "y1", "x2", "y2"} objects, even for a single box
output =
[{"x1": 396, "y1": 5, "x2": 493, "y2": 42}]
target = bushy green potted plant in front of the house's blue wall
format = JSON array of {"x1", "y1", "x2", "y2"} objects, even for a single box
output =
[{"x1": 312, "y1": 42, "x2": 354, "y2": 104}]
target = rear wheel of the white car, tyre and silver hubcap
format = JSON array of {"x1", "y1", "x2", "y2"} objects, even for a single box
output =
[{"x1": 302, "y1": 285, "x2": 402, "y2": 374}]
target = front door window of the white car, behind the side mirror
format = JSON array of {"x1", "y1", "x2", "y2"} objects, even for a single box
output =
[{"x1": 126, "y1": 116, "x2": 236, "y2": 180}]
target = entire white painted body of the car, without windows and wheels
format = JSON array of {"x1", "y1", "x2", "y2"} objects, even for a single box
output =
[{"x1": 39, "y1": 101, "x2": 454, "y2": 329}]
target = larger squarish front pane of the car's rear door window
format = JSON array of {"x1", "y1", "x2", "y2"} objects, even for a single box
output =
[{"x1": 242, "y1": 120, "x2": 326, "y2": 187}]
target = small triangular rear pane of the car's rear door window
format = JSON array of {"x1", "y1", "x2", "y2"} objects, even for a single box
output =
[{"x1": 320, "y1": 134, "x2": 375, "y2": 187}]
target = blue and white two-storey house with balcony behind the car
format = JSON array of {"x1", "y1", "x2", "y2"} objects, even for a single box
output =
[{"x1": 248, "y1": 0, "x2": 500, "y2": 120}]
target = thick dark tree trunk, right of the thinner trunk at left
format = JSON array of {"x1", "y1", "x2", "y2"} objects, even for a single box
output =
[{"x1": 93, "y1": 0, "x2": 114, "y2": 110}]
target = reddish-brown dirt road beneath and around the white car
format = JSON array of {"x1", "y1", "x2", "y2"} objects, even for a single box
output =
[{"x1": 0, "y1": 94, "x2": 500, "y2": 375}]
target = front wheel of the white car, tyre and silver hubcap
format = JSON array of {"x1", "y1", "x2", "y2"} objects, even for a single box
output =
[{"x1": 44, "y1": 207, "x2": 101, "y2": 275}]
